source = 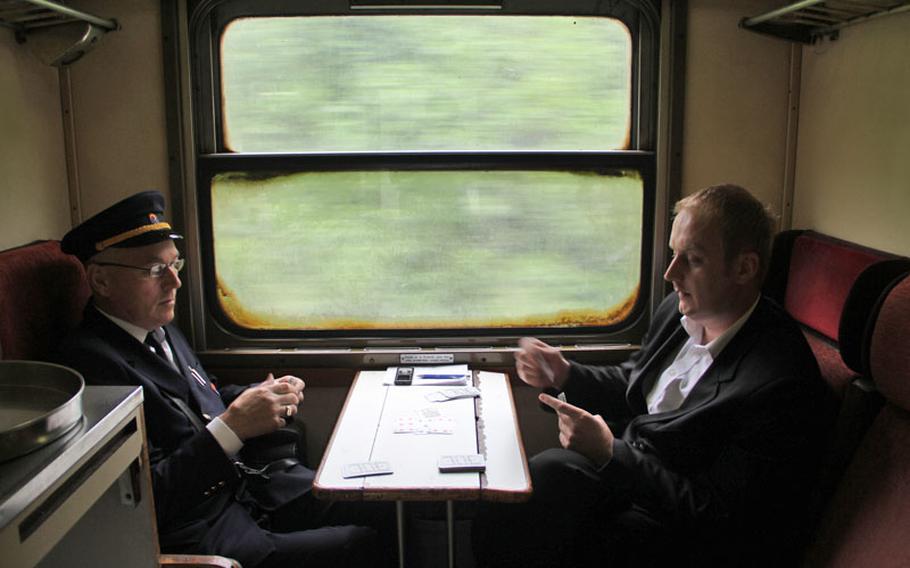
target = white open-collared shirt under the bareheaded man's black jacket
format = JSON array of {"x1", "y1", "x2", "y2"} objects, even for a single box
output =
[{"x1": 645, "y1": 298, "x2": 759, "y2": 414}]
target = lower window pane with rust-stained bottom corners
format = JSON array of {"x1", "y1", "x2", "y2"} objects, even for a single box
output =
[{"x1": 211, "y1": 170, "x2": 643, "y2": 330}]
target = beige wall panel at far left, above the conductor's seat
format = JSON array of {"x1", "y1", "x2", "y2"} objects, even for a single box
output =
[{"x1": 0, "y1": 28, "x2": 70, "y2": 250}]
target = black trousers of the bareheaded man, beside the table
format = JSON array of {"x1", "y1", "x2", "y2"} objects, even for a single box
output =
[{"x1": 472, "y1": 449, "x2": 666, "y2": 568}]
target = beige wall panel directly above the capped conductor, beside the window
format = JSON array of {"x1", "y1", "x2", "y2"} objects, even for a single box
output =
[{"x1": 71, "y1": 0, "x2": 169, "y2": 219}]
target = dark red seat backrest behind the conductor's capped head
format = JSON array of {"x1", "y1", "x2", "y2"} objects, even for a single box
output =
[{"x1": 0, "y1": 241, "x2": 90, "y2": 361}]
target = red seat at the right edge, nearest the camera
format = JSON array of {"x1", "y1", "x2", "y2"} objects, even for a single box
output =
[{"x1": 806, "y1": 277, "x2": 910, "y2": 568}]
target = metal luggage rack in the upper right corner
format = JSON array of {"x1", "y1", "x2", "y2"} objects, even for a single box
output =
[{"x1": 739, "y1": 0, "x2": 910, "y2": 44}]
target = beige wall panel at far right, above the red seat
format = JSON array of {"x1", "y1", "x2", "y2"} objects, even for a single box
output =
[{"x1": 793, "y1": 13, "x2": 910, "y2": 255}]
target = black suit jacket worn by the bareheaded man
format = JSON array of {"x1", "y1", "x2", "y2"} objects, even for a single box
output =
[{"x1": 564, "y1": 293, "x2": 833, "y2": 563}]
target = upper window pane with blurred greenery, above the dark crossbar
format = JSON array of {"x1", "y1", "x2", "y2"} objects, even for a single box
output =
[{"x1": 221, "y1": 15, "x2": 632, "y2": 152}]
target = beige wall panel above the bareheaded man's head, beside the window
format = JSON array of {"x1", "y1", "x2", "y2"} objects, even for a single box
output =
[{"x1": 682, "y1": 0, "x2": 790, "y2": 214}]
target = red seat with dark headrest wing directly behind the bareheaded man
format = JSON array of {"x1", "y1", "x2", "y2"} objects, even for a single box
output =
[{"x1": 764, "y1": 230, "x2": 910, "y2": 552}]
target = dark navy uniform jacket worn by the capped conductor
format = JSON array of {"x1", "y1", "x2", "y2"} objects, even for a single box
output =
[{"x1": 59, "y1": 303, "x2": 313, "y2": 565}]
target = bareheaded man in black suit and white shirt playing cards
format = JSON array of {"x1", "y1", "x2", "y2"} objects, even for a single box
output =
[{"x1": 475, "y1": 185, "x2": 831, "y2": 566}]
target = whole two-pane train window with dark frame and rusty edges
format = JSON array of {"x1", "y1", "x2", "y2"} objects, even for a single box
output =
[{"x1": 191, "y1": 1, "x2": 656, "y2": 344}]
